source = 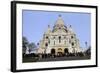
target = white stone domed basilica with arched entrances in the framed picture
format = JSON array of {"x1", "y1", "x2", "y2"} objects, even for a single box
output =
[{"x1": 38, "y1": 15, "x2": 81, "y2": 55}]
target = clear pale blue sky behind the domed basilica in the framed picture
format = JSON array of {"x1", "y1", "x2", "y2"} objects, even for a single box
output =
[{"x1": 23, "y1": 10, "x2": 91, "y2": 48}]
